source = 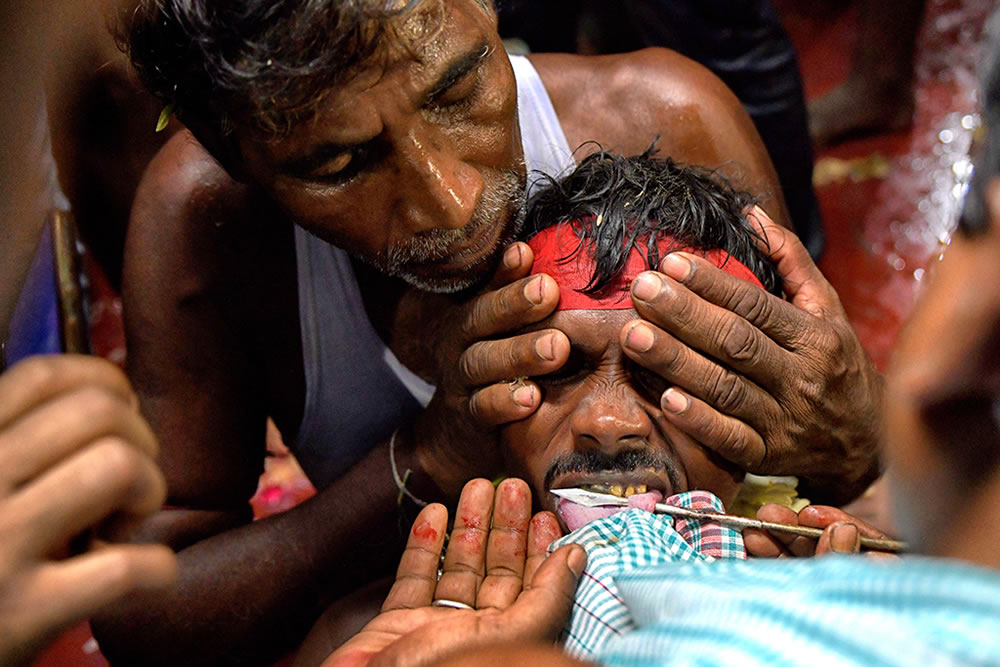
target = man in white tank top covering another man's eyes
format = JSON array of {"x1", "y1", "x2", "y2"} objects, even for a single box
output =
[{"x1": 95, "y1": 0, "x2": 882, "y2": 664}]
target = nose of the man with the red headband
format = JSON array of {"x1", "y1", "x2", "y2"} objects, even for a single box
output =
[{"x1": 570, "y1": 382, "x2": 653, "y2": 456}]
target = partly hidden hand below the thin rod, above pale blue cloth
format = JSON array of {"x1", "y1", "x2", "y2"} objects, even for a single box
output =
[{"x1": 743, "y1": 504, "x2": 897, "y2": 558}]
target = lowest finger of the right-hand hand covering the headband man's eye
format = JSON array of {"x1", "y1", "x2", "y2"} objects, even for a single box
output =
[{"x1": 660, "y1": 387, "x2": 772, "y2": 475}]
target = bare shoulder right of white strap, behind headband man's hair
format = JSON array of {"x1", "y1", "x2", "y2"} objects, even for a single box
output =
[{"x1": 531, "y1": 48, "x2": 787, "y2": 223}]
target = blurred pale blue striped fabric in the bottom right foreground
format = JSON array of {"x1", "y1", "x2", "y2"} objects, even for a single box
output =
[{"x1": 591, "y1": 556, "x2": 1000, "y2": 667}]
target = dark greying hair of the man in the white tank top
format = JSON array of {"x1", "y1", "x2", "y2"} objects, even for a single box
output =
[{"x1": 114, "y1": 0, "x2": 492, "y2": 140}]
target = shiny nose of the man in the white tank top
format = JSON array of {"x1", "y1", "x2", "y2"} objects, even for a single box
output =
[{"x1": 399, "y1": 128, "x2": 484, "y2": 233}]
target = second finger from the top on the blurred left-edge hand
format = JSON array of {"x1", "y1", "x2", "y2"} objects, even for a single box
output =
[{"x1": 0, "y1": 384, "x2": 158, "y2": 493}]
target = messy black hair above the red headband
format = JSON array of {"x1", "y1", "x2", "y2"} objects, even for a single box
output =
[{"x1": 524, "y1": 143, "x2": 781, "y2": 294}]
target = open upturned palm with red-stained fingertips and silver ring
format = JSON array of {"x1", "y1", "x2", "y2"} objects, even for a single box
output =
[{"x1": 323, "y1": 479, "x2": 586, "y2": 667}]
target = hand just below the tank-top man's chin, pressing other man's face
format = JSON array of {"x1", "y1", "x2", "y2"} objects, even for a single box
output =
[{"x1": 413, "y1": 243, "x2": 570, "y2": 497}]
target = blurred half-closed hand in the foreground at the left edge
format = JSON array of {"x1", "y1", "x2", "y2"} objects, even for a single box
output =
[{"x1": 0, "y1": 356, "x2": 177, "y2": 665}]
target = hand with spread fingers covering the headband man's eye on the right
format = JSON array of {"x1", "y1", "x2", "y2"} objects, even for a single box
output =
[{"x1": 621, "y1": 208, "x2": 883, "y2": 505}]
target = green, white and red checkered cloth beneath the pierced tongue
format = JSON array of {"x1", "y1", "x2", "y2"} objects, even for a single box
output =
[{"x1": 549, "y1": 491, "x2": 746, "y2": 659}]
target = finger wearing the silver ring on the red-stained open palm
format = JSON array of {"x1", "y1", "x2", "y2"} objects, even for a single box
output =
[{"x1": 434, "y1": 479, "x2": 493, "y2": 606}]
